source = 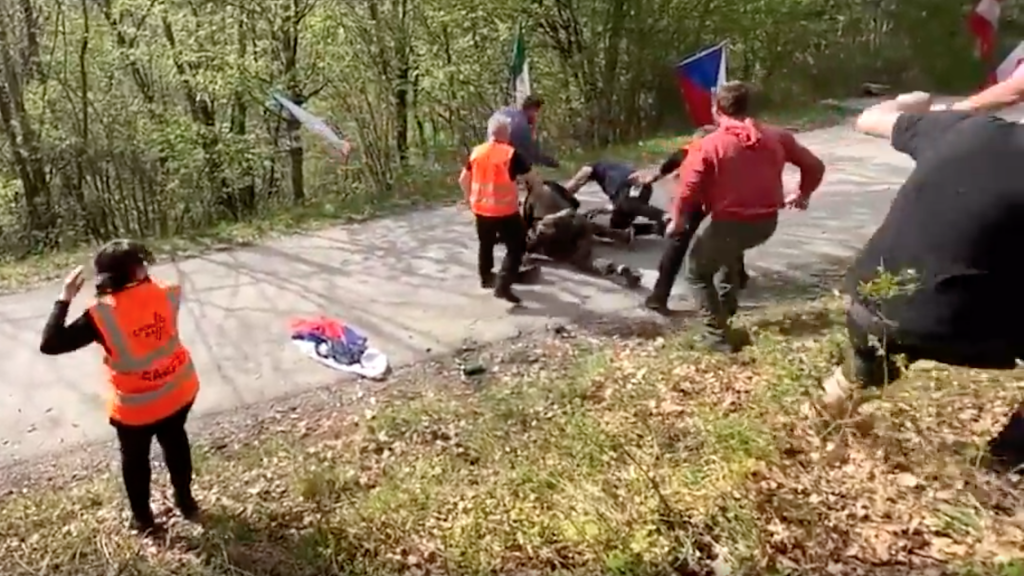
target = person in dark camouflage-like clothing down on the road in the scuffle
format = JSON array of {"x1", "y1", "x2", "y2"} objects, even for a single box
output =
[{"x1": 523, "y1": 181, "x2": 640, "y2": 288}]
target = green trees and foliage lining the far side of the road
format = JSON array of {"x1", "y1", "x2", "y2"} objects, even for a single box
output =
[{"x1": 0, "y1": 0, "x2": 981, "y2": 256}]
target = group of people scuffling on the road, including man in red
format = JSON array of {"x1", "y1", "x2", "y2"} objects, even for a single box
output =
[{"x1": 468, "y1": 82, "x2": 824, "y2": 351}]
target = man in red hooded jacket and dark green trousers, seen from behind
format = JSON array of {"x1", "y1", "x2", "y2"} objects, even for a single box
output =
[{"x1": 645, "y1": 82, "x2": 825, "y2": 352}]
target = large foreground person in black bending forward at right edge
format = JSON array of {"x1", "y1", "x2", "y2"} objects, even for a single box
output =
[{"x1": 825, "y1": 93, "x2": 1024, "y2": 468}]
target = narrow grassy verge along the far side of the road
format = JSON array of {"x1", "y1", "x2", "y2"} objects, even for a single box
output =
[{"x1": 0, "y1": 105, "x2": 849, "y2": 291}]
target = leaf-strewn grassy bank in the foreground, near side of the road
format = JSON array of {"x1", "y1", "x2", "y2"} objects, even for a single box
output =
[{"x1": 0, "y1": 293, "x2": 1024, "y2": 576}]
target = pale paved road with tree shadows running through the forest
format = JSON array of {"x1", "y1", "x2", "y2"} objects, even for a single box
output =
[{"x1": 0, "y1": 100, "x2": 1019, "y2": 465}]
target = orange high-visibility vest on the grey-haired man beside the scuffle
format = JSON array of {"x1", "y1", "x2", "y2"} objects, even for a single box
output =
[{"x1": 469, "y1": 142, "x2": 519, "y2": 216}]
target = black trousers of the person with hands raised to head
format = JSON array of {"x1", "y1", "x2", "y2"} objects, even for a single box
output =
[{"x1": 111, "y1": 403, "x2": 193, "y2": 523}]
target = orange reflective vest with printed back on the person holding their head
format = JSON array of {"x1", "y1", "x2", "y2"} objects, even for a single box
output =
[{"x1": 89, "y1": 281, "x2": 199, "y2": 425}]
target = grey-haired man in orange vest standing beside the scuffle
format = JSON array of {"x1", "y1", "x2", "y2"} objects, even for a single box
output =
[{"x1": 459, "y1": 109, "x2": 542, "y2": 304}]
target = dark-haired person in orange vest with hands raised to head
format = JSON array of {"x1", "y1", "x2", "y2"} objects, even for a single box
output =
[{"x1": 39, "y1": 240, "x2": 200, "y2": 534}]
